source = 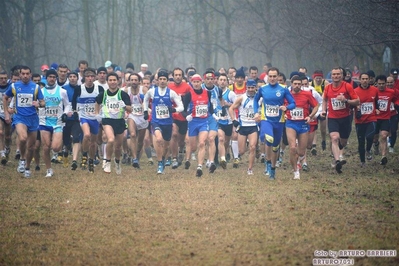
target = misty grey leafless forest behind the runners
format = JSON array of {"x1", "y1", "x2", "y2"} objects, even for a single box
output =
[{"x1": 0, "y1": 0, "x2": 399, "y2": 73}]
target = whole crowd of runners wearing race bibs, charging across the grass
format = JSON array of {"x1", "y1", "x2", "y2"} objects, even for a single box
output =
[{"x1": 0, "y1": 60, "x2": 399, "y2": 180}]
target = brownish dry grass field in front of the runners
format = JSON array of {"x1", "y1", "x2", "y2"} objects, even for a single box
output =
[{"x1": 0, "y1": 138, "x2": 399, "y2": 265}]
